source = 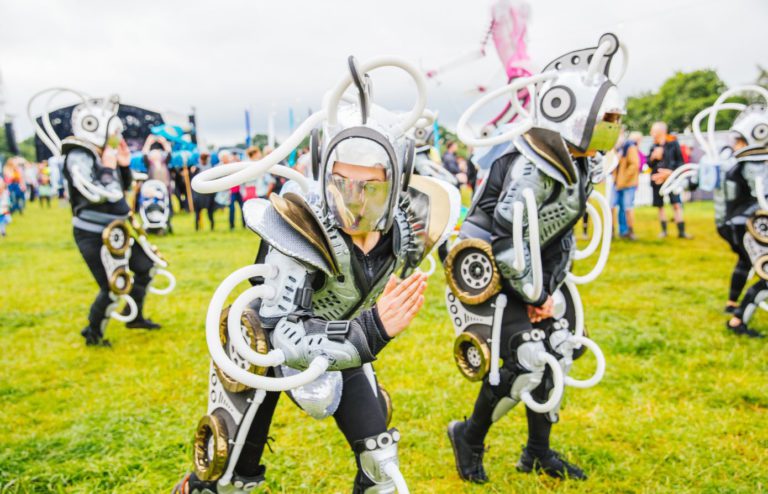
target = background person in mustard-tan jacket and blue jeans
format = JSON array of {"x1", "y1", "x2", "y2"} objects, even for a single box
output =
[{"x1": 613, "y1": 132, "x2": 643, "y2": 240}]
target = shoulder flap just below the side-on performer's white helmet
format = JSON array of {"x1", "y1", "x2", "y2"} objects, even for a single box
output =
[{"x1": 514, "y1": 128, "x2": 579, "y2": 187}]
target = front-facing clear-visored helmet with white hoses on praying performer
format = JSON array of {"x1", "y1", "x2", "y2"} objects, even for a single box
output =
[{"x1": 192, "y1": 57, "x2": 434, "y2": 236}]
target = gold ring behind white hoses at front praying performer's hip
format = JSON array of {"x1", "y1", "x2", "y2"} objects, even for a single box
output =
[{"x1": 213, "y1": 307, "x2": 269, "y2": 393}]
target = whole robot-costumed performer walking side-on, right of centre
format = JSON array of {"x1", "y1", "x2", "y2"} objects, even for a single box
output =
[{"x1": 445, "y1": 34, "x2": 627, "y2": 483}]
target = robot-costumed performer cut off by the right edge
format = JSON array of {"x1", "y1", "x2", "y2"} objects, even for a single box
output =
[{"x1": 656, "y1": 86, "x2": 768, "y2": 337}]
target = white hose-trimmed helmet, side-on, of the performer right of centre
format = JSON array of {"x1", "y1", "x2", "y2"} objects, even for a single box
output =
[{"x1": 457, "y1": 33, "x2": 628, "y2": 153}]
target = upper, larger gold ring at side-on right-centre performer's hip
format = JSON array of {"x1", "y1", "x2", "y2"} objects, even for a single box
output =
[{"x1": 445, "y1": 238, "x2": 501, "y2": 305}]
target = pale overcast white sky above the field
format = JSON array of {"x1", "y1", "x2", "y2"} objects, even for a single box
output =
[{"x1": 0, "y1": 0, "x2": 768, "y2": 144}]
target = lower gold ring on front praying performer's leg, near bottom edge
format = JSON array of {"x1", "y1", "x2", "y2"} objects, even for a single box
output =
[{"x1": 194, "y1": 415, "x2": 229, "y2": 481}]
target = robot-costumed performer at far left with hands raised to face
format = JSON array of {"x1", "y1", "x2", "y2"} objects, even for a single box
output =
[{"x1": 27, "y1": 88, "x2": 175, "y2": 346}]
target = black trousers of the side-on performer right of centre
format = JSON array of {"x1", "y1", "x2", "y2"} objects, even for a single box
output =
[{"x1": 465, "y1": 296, "x2": 552, "y2": 455}]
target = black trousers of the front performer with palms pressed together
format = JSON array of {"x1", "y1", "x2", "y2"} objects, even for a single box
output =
[{"x1": 235, "y1": 367, "x2": 387, "y2": 476}]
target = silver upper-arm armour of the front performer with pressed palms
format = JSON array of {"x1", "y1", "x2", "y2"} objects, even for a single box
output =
[{"x1": 259, "y1": 248, "x2": 310, "y2": 326}]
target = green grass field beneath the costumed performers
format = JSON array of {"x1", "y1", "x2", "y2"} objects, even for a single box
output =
[{"x1": 0, "y1": 199, "x2": 768, "y2": 493}]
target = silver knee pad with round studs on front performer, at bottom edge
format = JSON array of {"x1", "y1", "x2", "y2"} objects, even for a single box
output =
[{"x1": 354, "y1": 428, "x2": 400, "y2": 494}]
